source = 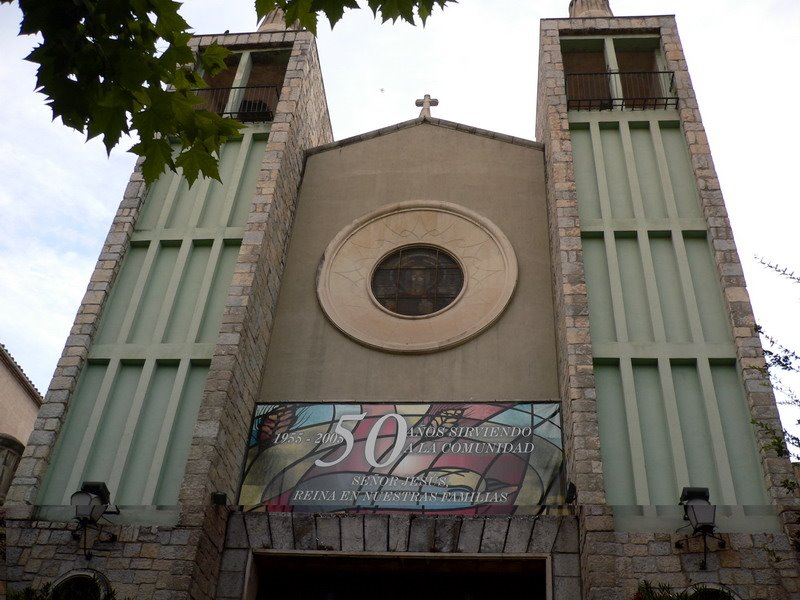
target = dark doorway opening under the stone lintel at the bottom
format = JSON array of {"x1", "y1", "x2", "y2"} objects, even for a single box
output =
[{"x1": 254, "y1": 553, "x2": 547, "y2": 600}]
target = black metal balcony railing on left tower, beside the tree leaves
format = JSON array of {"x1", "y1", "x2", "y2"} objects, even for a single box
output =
[{"x1": 194, "y1": 85, "x2": 279, "y2": 123}]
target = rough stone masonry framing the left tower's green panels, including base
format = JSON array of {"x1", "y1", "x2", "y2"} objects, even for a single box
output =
[{"x1": 6, "y1": 31, "x2": 332, "y2": 600}]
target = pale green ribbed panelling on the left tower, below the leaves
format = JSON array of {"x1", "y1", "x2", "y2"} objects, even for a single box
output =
[{"x1": 39, "y1": 129, "x2": 268, "y2": 521}]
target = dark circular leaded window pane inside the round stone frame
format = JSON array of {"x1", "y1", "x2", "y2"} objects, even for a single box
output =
[{"x1": 372, "y1": 246, "x2": 464, "y2": 317}]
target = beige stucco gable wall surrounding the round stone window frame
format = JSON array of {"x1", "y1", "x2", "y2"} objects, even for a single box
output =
[{"x1": 259, "y1": 123, "x2": 558, "y2": 402}]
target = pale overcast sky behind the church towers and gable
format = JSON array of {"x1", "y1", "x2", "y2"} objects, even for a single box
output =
[{"x1": 0, "y1": 0, "x2": 800, "y2": 436}]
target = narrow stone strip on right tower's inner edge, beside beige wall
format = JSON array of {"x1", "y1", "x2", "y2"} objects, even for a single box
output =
[{"x1": 536, "y1": 14, "x2": 615, "y2": 598}]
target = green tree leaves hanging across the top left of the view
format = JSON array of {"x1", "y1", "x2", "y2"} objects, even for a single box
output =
[{"x1": 0, "y1": 0, "x2": 455, "y2": 184}]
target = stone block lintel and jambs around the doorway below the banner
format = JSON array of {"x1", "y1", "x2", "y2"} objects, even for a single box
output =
[{"x1": 217, "y1": 512, "x2": 581, "y2": 600}]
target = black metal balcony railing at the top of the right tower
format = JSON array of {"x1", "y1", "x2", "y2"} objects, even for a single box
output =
[{"x1": 566, "y1": 71, "x2": 678, "y2": 110}]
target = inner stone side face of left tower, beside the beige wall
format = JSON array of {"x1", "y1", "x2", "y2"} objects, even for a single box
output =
[{"x1": 180, "y1": 32, "x2": 333, "y2": 598}]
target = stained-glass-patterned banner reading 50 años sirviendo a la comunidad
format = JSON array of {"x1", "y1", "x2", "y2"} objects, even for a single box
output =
[{"x1": 239, "y1": 402, "x2": 564, "y2": 515}]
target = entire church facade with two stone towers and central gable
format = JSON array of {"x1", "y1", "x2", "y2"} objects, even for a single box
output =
[{"x1": 6, "y1": 1, "x2": 800, "y2": 600}]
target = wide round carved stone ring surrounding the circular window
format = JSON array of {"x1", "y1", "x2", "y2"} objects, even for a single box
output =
[{"x1": 317, "y1": 200, "x2": 518, "y2": 353}]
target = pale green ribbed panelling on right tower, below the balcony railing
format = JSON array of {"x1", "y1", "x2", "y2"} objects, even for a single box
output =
[{"x1": 569, "y1": 104, "x2": 780, "y2": 531}]
